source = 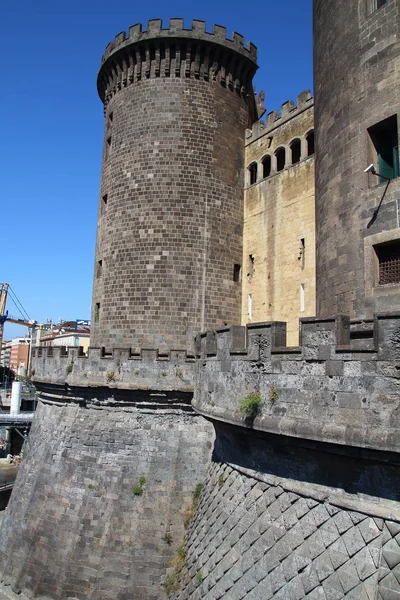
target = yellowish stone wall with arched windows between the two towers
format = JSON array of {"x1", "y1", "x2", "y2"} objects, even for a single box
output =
[{"x1": 242, "y1": 92, "x2": 315, "y2": 345}]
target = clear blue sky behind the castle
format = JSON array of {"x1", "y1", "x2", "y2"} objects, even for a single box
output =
[{"x1": 0, "y1": 0, "x2": 312, "y2": 339}]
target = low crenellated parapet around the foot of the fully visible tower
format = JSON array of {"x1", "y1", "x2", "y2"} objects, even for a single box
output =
[{"x1": 32, "y1": 346, "x2": 195, "y2": 392}]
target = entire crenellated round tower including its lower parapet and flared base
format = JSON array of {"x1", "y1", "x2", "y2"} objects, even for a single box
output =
[{"x1": 0, "y1": 19, "x2": 256, "y2": 600}]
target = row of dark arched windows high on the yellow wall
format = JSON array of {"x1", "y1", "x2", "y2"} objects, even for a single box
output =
[{"x1": 248, "y1": 129, "x2": 314, "y2": 185}]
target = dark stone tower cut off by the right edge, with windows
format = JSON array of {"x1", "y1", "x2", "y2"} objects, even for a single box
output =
[{"x1": 314, "y1": 0, "x2": 400, "y2": 318}]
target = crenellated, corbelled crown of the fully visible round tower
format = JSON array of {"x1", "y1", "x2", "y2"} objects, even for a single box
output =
[{"x1": 98, "y1": 19, "x2": 257, "y2": 105}]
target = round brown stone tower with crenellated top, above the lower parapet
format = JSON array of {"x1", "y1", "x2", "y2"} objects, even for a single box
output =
[{"x1": 91, "y1": 19, "x2": 257, "y2": 350}]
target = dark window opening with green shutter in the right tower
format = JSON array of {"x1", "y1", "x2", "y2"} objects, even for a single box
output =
[{"x1": 368, "y1": 115, "x2": 399, "y2": 183}]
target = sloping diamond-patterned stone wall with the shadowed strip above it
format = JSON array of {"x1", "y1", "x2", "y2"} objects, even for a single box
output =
[{"x1": 171, "y1": 426, "x2": 400, "y2": 600}]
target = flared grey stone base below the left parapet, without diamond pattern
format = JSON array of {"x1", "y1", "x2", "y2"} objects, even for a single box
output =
[{"x1": 0, "y1": 404, "x2": 213, "y2": 600}]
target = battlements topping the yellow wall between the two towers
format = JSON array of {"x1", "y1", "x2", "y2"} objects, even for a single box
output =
[{"x1": 246, "y1": 90, "x2": 314, "y2": 144}]
